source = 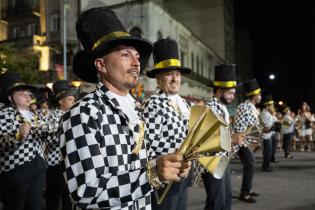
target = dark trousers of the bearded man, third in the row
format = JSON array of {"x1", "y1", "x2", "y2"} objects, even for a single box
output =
[{"x1": 201, "y1": 164, "x2": 232, "y2": 210}]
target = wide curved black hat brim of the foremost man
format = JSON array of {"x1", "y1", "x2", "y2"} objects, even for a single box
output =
[{"x1": 73, "y1": 36, "x2": 153, "y2": 83}]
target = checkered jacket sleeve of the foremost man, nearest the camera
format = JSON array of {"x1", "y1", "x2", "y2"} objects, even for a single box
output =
[{"x1": 59, "y1": 103, "x2": 151, "y2": 209}]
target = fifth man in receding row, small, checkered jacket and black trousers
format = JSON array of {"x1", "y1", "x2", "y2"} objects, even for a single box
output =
[{"x1": 259, "y1": 95, "x2": 275, "y2": 172}]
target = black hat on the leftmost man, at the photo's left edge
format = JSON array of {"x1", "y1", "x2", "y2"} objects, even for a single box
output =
[{"x1": 0, "y1": 72, "x2": 37, "y2": 98}]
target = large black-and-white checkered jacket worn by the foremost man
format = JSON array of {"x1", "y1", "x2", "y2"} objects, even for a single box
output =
[{"x1": 60, "y1": 83, "x2": 152, "y2": 209}]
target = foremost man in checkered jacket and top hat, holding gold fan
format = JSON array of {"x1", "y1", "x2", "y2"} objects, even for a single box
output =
[{"x1": 59, "y1": 7, "x2": 189, "y2": 210}]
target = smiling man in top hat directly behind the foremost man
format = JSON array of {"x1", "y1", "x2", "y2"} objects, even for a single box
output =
[{"x1": 142, "y1": 38, "x2": 191, "y2": 210}]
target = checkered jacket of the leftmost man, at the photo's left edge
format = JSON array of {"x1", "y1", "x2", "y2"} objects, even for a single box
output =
[{"x1": 0, "y1": 106, "x2": 43, "y2": 173}]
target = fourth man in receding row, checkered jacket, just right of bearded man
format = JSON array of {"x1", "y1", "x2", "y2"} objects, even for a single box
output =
[{"x1": 233, "y1": 79, "x2": 261, "y2": 203}]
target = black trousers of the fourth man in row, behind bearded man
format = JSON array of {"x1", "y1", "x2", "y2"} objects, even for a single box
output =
[{"x1": 238, "y1": 147, "x2": 256, "y2": 194}]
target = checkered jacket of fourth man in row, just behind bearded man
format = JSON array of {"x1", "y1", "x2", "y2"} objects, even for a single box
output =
[{"x1": 233, "y1": 100, "x2": 259, "y2": 133}]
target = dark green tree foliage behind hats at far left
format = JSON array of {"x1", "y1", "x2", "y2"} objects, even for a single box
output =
[{"x1": 0, "y1": 45, "x2": 44, "y2": 84}]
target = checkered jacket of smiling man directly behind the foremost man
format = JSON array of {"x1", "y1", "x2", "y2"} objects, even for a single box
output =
[{"x1": 142, "y1": 91, "x2": 190, "y2": 155}]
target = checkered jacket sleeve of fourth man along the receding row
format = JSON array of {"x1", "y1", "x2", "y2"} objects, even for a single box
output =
[{"x1": 233, "y1": 103, "x2": 256, "y2": 133}]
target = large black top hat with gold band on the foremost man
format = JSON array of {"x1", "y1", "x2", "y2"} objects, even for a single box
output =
[{"x1": 73, "y1": 7, "x2": 153, "y2": 83}]
